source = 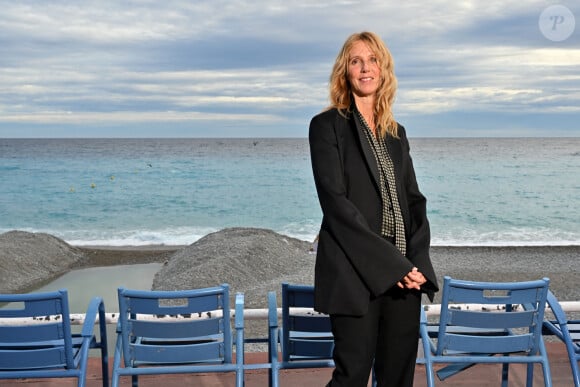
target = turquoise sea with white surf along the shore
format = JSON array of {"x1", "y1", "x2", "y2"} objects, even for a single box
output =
[{"x1": 0, "y1": 138, "x2": 580, "y2": 246}]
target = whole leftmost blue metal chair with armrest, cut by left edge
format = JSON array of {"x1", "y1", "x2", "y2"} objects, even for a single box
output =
[{"x1": 0, "y1": 289, "x2": 109, "y2": 387}]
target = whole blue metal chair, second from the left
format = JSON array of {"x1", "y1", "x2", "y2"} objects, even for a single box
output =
[{"x1": 113, "y1": 284, "x2": 244, "y2": 387}]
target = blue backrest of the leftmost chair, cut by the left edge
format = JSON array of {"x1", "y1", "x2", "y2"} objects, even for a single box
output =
[{"x1": 0, "y1": 289, "x2": 75, "y2": 370}]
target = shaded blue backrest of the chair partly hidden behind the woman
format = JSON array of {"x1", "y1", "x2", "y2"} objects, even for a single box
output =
[{"x1": 281, "y1": 283, "x2": 334, "y2": 362}]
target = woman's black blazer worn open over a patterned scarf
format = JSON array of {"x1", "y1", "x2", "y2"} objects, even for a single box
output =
[{"x1": 309, "y1": 109, "x2": 438, "y2": 315}]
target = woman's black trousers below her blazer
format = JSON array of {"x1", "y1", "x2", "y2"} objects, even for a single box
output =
[{"x1": 327, "y1": 287, "x2": 421, "y2": 387}]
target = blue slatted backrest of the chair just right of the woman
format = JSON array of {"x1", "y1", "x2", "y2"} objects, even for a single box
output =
[{"x1": 436, "y1": 276, "x2": 549, "y2": 354}]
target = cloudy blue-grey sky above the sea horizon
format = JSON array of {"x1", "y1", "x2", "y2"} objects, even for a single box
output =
[{"x1": 0, "y1": 0, "x2": 580, "y2": 137}]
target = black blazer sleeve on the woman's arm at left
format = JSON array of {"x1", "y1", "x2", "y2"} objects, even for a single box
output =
[{"x1": 309, "y1": 112, "x2": 413, "y2": 296}]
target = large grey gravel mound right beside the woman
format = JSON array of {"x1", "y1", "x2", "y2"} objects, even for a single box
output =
[{"x1": 153, "y1": 228, "x2": 315, "y2": 308}]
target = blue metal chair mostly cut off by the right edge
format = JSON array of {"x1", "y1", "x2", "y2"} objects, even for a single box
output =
[{"x1": 544, "y1": 291, "x2": 580, "y2": 387}]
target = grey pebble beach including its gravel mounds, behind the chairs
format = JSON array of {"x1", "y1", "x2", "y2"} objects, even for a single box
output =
[{"x1": 0, "y1": 228, "x2": 580, "y2": 304}]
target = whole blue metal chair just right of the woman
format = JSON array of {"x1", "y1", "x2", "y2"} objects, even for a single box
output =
[{"x1": 420, "y1": 276, "x2": 552, "y2": 387}]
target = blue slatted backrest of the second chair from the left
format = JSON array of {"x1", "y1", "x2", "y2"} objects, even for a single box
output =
[{"x1": 118, "y1": 284, "x2": 233, "y2": 367}]
